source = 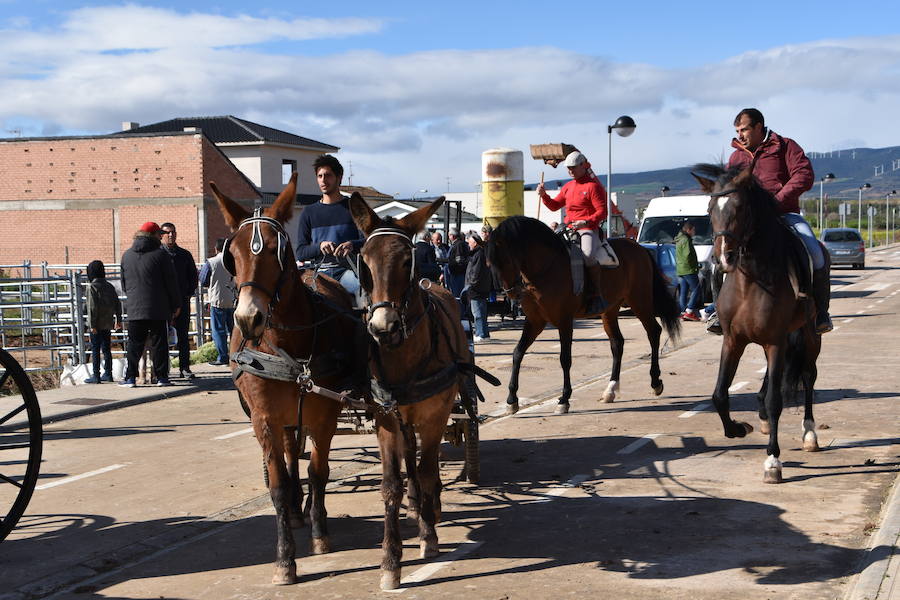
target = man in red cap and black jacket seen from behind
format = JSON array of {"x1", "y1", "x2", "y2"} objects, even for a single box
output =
[{"x1": 119, "y1": 221, "x2": 181, "y2": 387}]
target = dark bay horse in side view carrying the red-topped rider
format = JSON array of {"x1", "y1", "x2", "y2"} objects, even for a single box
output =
[{"x1": 487, "y1": 217, "x2": 681, "y2": 414}]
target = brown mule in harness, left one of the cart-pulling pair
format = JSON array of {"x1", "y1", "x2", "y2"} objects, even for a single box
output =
[{"x1": 210, "y1": 173, "x2": 366, "y2": 584}]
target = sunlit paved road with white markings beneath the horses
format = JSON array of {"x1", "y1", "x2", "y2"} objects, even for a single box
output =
[{"x1": 0, "y1": 249, "x2": 900, "y2": 600}]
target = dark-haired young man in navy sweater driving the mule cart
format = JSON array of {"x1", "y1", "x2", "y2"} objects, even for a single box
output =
[{"x1": 295, "y1": 154, "x2": 365, "y2": 295}]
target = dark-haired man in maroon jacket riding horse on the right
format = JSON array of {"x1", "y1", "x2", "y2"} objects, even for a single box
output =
[{"x1": 728, "y1": 108, "x2": 833, "y2": 334}]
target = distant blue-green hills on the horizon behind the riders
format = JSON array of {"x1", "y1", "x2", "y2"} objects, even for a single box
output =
[{"x1": 526, "y1": 146, "x2": 900, "y2": 205}]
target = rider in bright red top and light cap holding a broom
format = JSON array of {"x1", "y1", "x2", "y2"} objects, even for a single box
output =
[{"x1": 537, "y1": 150, "x2": 619, "y2": 313}]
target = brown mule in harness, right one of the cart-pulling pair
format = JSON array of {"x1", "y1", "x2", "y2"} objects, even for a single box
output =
[{"x1": 350, "y1": 194, "x2": 471, "y2": 590}]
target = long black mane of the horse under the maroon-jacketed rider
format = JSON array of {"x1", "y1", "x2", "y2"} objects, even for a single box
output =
[{"x1": 692, "y1": 164, "x2": 796, "y2": 282}]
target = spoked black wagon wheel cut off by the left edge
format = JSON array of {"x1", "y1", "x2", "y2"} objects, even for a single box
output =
[{"x1": 0, "y1": 350, "x2": 43, "y2": 541}]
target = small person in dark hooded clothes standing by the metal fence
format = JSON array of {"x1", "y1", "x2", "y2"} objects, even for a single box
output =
[{"x1": 84, "y1": 260, "x2": 122, "y2": 383}]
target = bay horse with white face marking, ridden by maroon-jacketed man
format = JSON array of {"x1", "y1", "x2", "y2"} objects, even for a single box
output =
[{"x1": 694, "y1": 165, "x2": 828, "y2": 483}]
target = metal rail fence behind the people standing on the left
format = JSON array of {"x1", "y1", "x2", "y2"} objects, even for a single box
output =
[{"x1": 0, "y1": 261, "x2": 210, "y2": 371}]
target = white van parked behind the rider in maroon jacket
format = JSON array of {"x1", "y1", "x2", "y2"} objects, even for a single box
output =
[{"x1": 637, "y1": 196, "x2": 712, "y2": 299}]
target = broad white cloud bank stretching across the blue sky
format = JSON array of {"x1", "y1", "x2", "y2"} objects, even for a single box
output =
[{"x1": 0, "y1": 5, "x2": 900, "y2": 193}]
